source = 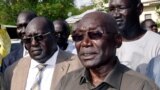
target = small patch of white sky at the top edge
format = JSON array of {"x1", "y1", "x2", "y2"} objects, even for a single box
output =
[{"x1": 74, "y1": 0, "x2": 92, "y2": 8}]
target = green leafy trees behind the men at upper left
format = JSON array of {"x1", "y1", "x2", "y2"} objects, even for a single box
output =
[{"x1": 0, "y1": 0, "x2": 81, "y2": 25}]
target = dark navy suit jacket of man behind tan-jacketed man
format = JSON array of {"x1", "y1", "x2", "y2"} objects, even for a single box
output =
[{"x1": 1, "y1": 43, "x2": 24, "y2": 73}]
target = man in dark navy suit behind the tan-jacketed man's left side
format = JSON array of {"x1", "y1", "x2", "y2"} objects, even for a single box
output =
[{"x1": 1, "y1": 11, "x2": 37, "y2": 72}]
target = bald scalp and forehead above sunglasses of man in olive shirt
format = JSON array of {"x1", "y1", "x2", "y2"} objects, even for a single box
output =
[{"x1": 77, "y1": 11, "x2": 118, "y2": 33}]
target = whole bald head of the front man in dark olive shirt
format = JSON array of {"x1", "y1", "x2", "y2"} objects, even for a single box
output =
[{"x1": 72, "y1": 11, "x2": 122, "y2": 68}]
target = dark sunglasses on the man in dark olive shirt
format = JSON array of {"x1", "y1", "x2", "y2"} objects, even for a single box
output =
[{"x1": 72, "y1": 31, "x2": 104, "y2": 42}]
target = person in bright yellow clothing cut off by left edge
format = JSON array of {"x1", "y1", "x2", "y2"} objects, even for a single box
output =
[{"x1": 0, "y1": 26, "x2": 11, "y2": 67}]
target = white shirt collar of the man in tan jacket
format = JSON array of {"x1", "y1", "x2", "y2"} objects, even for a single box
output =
[{"x1": 31, "y1": 46, "x2": 59, "y2": 68}]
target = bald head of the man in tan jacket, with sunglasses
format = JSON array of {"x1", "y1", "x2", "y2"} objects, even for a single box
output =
[{"x1": 23, "y1": 17, "x2": 57, "y2": 63}]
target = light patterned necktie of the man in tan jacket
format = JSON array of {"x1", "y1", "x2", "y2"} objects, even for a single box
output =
[{"x1": 31, "y1": 64, "x2": 46, "y2": 90}]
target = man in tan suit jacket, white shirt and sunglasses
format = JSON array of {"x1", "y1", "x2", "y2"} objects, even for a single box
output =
[{"x1": 4, "y1": 17, "x2": 81, "y2": 90}]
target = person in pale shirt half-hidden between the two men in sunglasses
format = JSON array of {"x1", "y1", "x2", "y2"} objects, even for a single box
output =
[{"x1": 53, "y1": 20, "x2": 76, "y2": 54}]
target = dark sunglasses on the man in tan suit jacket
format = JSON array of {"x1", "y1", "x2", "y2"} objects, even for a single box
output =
[{"x1": 22, "y1": 32, "x2": 51, "y2": 44}]
